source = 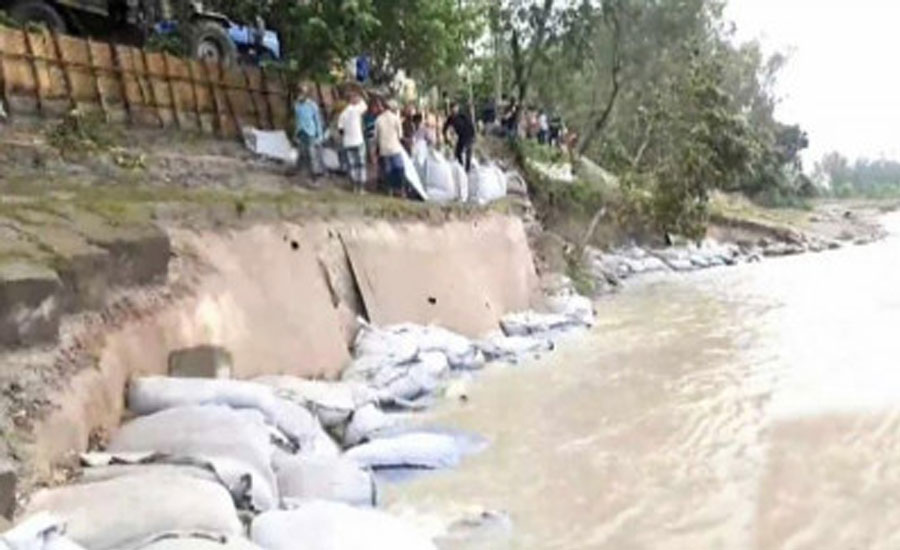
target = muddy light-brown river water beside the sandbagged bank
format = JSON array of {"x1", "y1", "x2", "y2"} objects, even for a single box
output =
[{"x1": 387, "y1": 217, "x2": 900, "y2": 550}]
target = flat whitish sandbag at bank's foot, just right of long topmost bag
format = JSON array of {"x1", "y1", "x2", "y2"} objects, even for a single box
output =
[{"x1": 254, "y1": 376, "x2": 376, "y2": 428}]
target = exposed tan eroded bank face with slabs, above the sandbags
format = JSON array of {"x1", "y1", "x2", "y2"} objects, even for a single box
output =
[{"x1": 19, "y1": 214, "x2": 539, "y2": 488}]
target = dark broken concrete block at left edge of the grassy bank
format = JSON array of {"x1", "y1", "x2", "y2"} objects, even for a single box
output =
[{"x1": 0, "y1": 259, "x2": 62, "y2": 347}]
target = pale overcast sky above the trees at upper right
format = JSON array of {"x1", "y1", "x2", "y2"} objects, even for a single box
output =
[{"x1": 726, "y1": 0, "x2": 900, "y2": 167}]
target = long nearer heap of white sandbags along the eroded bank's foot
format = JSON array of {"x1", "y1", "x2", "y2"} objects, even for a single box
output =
[{"x1": 7, "y1": 296, "x2": 593, "y2": 550}]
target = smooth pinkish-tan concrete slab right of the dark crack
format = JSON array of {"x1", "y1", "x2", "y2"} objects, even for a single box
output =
[{"x1": 341, "y1": 216, "x2": 539, "y2": 336}]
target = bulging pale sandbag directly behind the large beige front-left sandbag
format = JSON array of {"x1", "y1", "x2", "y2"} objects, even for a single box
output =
[{"x1": 107, "y1": 405, "x2": 278, "y2": 510}]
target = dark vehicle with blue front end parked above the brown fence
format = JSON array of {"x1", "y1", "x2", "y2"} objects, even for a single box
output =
[{"x1": 0, "y1": 0, "x2": 281, "y2": 65}]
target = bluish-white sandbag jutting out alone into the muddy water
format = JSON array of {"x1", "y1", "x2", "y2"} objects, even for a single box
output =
[{"x1": 344, "y1": 432, "x2": 462, "y2": 470}]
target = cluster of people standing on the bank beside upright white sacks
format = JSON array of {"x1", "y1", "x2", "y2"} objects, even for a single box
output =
[{"x1": 294, "y1": 85, "x2": 477, "y2": 196}]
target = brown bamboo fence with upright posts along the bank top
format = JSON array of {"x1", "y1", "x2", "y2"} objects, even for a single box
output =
[{"x1": 0, "y1": 26, "x2": 330, "y2": 138}]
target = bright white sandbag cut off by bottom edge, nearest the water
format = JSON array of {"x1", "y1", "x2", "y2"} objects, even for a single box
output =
[{"x1": 250, "y1": 501, "x2": 437, "y2": 550}]
